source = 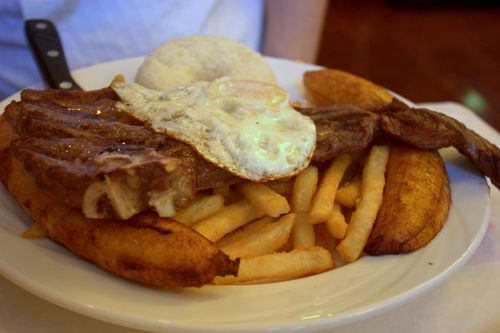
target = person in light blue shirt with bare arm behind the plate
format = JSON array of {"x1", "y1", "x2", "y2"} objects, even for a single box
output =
[{"x1": 0, "y1": 0, "x2": 327, "y2": 100}]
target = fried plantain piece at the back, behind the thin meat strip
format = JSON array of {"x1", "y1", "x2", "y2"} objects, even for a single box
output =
[{"x1": 303, "y1": 69, "x2": 392, "y2": 110}]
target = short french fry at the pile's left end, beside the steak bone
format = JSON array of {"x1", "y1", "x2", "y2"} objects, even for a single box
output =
[{"x1": 174, "y1": 194, "x2": 224, "y2": 225}]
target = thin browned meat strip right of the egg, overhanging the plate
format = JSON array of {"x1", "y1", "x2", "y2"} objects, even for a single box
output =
[{"x1": 298, "y1": 100, "x2": 500, "y2": 188}]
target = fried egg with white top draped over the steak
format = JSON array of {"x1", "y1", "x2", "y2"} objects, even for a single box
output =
[{"x1": 112, "y1": 77, "x2": 316, "y2": 181}]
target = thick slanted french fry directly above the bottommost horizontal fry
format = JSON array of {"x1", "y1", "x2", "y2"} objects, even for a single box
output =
[{"x1": 219, "y1": 213, "x2": 296, "y2": 259}]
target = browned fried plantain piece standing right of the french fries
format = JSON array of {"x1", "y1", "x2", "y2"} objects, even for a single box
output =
[{"x1": 365, "y1": 146, "x2": 450, "y2": 255}]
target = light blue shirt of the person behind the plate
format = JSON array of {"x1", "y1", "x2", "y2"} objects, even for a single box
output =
[{"x1": 0, "y1": 0, "x2": 264, "y2": 100}]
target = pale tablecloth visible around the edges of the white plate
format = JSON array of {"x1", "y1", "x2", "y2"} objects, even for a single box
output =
[{"x1": 0, "y1": 103, "x2": 500, "y2": 333}]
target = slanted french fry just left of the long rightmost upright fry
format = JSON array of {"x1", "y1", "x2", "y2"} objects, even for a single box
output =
[{"x1": 309, "y1": 154, "x2": 352, "y2": 224}]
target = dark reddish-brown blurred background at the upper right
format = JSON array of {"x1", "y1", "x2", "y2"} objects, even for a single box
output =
[{"x1": 317, "y1": 0, "x2": 500, "y2": 131}]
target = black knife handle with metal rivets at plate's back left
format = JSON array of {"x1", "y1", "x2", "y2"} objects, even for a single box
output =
[{"x1": 24, "y1": 19, "x2": 81, "y2": 90}]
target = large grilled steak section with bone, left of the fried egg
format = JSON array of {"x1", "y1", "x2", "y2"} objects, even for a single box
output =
[{"x1": 5, "y1": 88, "x2": 238, "y2": 218}]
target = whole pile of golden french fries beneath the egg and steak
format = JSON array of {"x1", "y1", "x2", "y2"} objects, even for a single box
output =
[{"x1": 175, "y1": 146, "x2": 389, "y2": 284}]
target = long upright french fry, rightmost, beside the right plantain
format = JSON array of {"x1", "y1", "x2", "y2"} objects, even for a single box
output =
[{"x1": 336, "y1": 146, "x2": 390, "y2": 262}]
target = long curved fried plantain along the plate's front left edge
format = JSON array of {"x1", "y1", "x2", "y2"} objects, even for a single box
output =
[{"x1": 0, "y1": 118, "x2": 238, "y2": 287}]
